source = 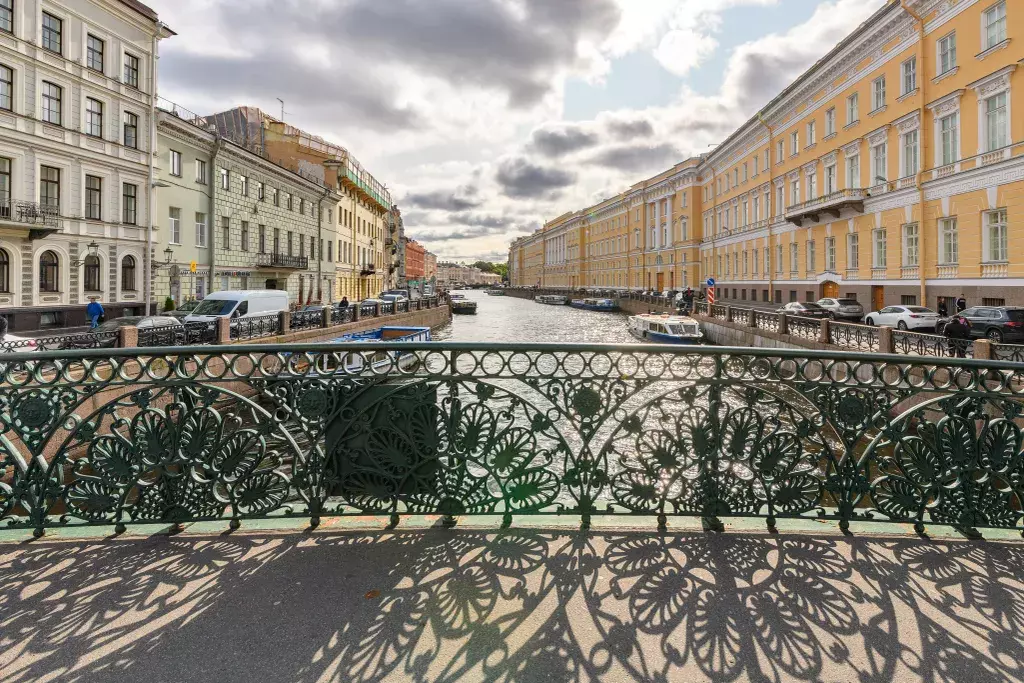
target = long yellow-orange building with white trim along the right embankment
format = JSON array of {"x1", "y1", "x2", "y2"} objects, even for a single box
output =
[{"x1": 509, "y1": 0, "x2": 1024, "y2": 315}]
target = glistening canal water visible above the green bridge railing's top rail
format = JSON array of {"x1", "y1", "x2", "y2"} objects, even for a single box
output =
[{"x1": 431, "y1": 291, "x2": 639, "y2": 344}]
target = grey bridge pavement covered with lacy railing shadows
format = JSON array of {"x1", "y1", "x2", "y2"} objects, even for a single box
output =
[{"x1": 0, "y1": 529, "x2": 1024, "y2": 683}]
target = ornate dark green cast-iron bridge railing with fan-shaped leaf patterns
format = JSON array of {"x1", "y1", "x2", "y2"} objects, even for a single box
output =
[{"x1": 0, "y1": 343, "x2": 1024, "y2": 535}]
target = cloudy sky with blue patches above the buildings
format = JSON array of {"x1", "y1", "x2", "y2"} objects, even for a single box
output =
[{"x1": 146, "y1": 0, "x2": 884, "y2": 261}]
